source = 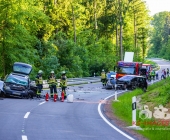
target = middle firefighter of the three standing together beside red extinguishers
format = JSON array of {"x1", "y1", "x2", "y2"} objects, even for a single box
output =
[{"x1": 48, "y1": 71, "x2": 57, "y2": 98}]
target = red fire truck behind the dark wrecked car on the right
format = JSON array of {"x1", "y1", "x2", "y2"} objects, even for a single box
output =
[{"x1": 115, "y1": 61, "x2": 142, "y2": 79}]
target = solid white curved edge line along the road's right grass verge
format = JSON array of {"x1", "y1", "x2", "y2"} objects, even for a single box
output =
[{"x1": 98, "y1": 92, "x2": 135, "y2": 140}]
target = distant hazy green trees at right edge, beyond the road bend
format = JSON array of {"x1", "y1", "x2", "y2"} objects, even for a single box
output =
[{"x1": 148, "y1": 11, "x2": 170, "y2": 60}]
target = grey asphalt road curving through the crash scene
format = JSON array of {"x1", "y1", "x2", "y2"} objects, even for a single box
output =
[{"x1": 0, "y1": 59, "x2": 170, "y2": 140}]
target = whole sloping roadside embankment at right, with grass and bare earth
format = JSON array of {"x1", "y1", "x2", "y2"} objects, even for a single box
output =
[{"x1": 111, "y1": 77, "x2": 170, "y2": 140}]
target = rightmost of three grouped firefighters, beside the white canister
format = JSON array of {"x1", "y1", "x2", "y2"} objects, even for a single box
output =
[{"x1": 60, "y1": 71, "x2": 67, "y2": 99}]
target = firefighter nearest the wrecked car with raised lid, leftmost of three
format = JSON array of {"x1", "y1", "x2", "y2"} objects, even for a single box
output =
[{"x1": 35, "y1": 70, "x2": 43, "y2": 98}]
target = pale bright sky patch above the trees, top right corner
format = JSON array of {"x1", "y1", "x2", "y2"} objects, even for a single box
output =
[{"x1": 145, "y1": 0, "x2": 170, "y2": 16}]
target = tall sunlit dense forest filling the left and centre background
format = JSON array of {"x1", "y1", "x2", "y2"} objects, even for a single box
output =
[{"x1": 0, "y1": 0, "x2": 153, "y2": 77}]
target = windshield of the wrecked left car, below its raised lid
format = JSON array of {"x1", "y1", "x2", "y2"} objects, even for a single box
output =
[{"x1": 5, "y1": 75, "x2": 28, "y2": 86}]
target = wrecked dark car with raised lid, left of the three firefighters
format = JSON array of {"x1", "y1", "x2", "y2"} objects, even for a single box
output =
[{"x1": 3, "y1": 62, "x2": 37, "y2": 98}]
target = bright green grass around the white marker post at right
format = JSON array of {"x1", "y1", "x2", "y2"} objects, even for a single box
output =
[{"x1": 112, "y1": 78, "x2": 170, "y2": 140}]
